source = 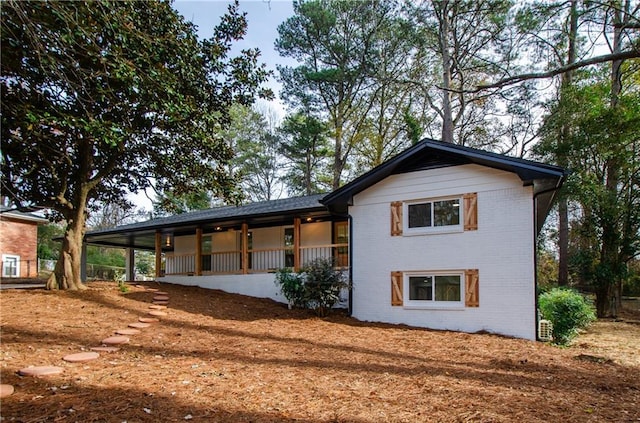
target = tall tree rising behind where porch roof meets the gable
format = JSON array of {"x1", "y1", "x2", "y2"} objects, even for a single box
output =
[{"x1": 276, "y1": 0, "x2": 395, "y2": 189}]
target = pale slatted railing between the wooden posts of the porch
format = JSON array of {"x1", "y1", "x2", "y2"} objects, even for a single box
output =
[{"x1": 165, "y1": 244, "x2": 349, "y2": 275}]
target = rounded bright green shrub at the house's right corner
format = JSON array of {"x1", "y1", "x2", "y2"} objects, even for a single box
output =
[{"x1": 538, "y1": 288, "x2": 596, "y2": 345}]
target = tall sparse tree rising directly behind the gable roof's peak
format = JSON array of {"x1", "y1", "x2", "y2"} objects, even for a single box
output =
[{"x1": 408, "y1": 0, "x2": 514, "y2": 148}]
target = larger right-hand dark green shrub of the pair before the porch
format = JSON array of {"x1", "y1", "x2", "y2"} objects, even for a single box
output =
[{"x1": 302, "y1": 259, "x2": 348, "y2": 317}]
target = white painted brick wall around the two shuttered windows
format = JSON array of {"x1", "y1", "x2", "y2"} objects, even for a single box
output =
[{"x1": 349, "y1": 165, "x2": 535, "y2": 339}]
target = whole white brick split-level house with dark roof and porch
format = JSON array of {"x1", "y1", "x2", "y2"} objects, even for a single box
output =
[{"x1": 86, "y1": 140, "x2": 565, "y2": 339}]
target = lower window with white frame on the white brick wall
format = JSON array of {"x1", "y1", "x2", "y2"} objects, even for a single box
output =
[{"x1": 404, "y1": 273, "x2": 464, "y2": 306}]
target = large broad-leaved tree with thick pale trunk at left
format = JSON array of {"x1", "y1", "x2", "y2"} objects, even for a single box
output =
[{"x1": 0, "y1": 1, "x2": 266, "y2": 289}]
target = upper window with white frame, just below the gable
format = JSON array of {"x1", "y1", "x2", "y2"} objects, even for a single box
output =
[{"x1": 406, "y1": 198, "x2": 461, "y2": 232}]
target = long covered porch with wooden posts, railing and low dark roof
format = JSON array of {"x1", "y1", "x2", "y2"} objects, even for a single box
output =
[{"x1": 85, "y1": 195, "x2": 349, "y2": 282}]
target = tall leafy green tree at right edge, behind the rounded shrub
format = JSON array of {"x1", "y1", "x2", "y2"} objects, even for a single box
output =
[{"x1": 537, "y1": 76, "x2": 640, "y2": 316}]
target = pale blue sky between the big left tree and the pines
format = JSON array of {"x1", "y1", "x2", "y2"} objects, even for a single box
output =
[{"x1": 173, "y1": 0, "x2": 296, "y2": 118}]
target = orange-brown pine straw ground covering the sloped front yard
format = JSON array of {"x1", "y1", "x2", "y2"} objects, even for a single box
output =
[{"x1": 0, "y1": 282, "x2": 640, "y2": 423}]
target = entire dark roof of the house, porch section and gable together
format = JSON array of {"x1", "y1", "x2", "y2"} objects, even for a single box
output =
[{"x1": 85, "y1": 139, "x2": 566, "y2": 249}]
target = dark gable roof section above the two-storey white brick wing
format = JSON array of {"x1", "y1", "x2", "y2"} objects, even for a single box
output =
[{"x1": 321, "y1": 139, "x2": 567, "y2": 230}]
